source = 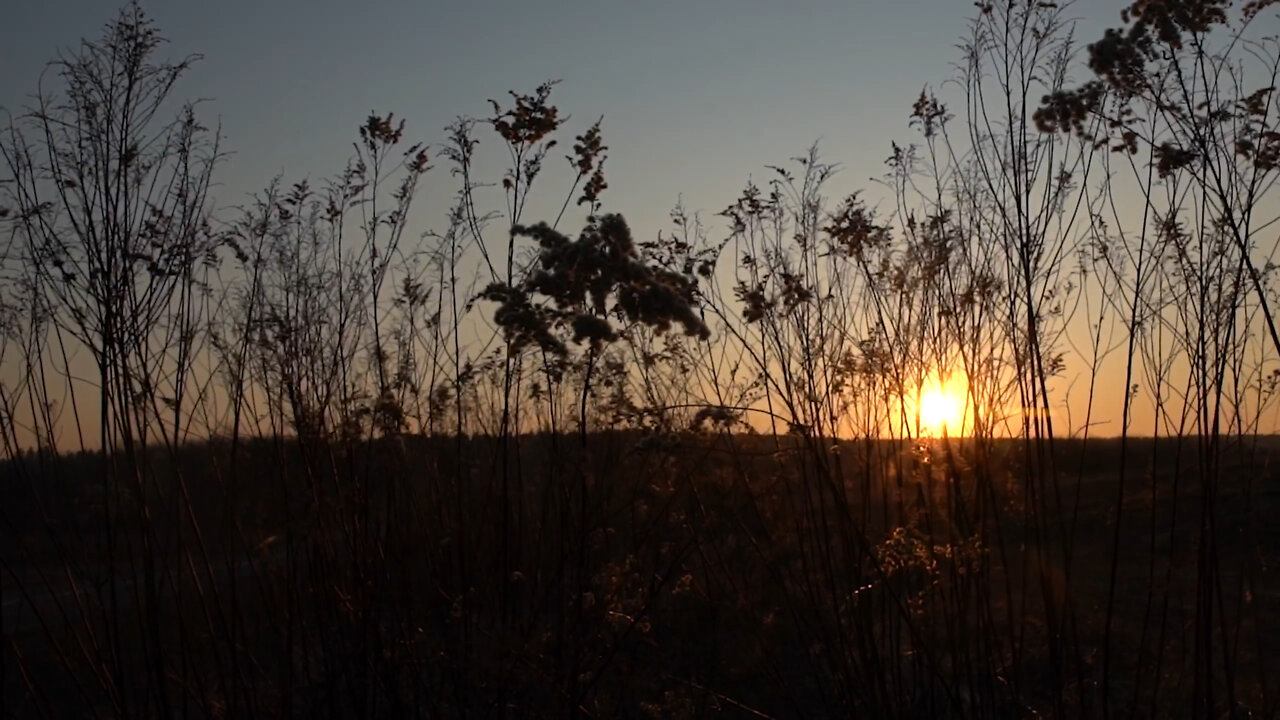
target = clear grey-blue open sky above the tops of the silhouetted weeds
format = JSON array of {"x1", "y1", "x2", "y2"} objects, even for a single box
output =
[{"x1": 0, "y1": 0, "x2": 1117, "y2": 234}]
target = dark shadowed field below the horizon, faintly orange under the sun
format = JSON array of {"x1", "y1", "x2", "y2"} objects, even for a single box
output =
[{"x1": 3, "y1": 433, "x2": 1280, "y2": 717}]
